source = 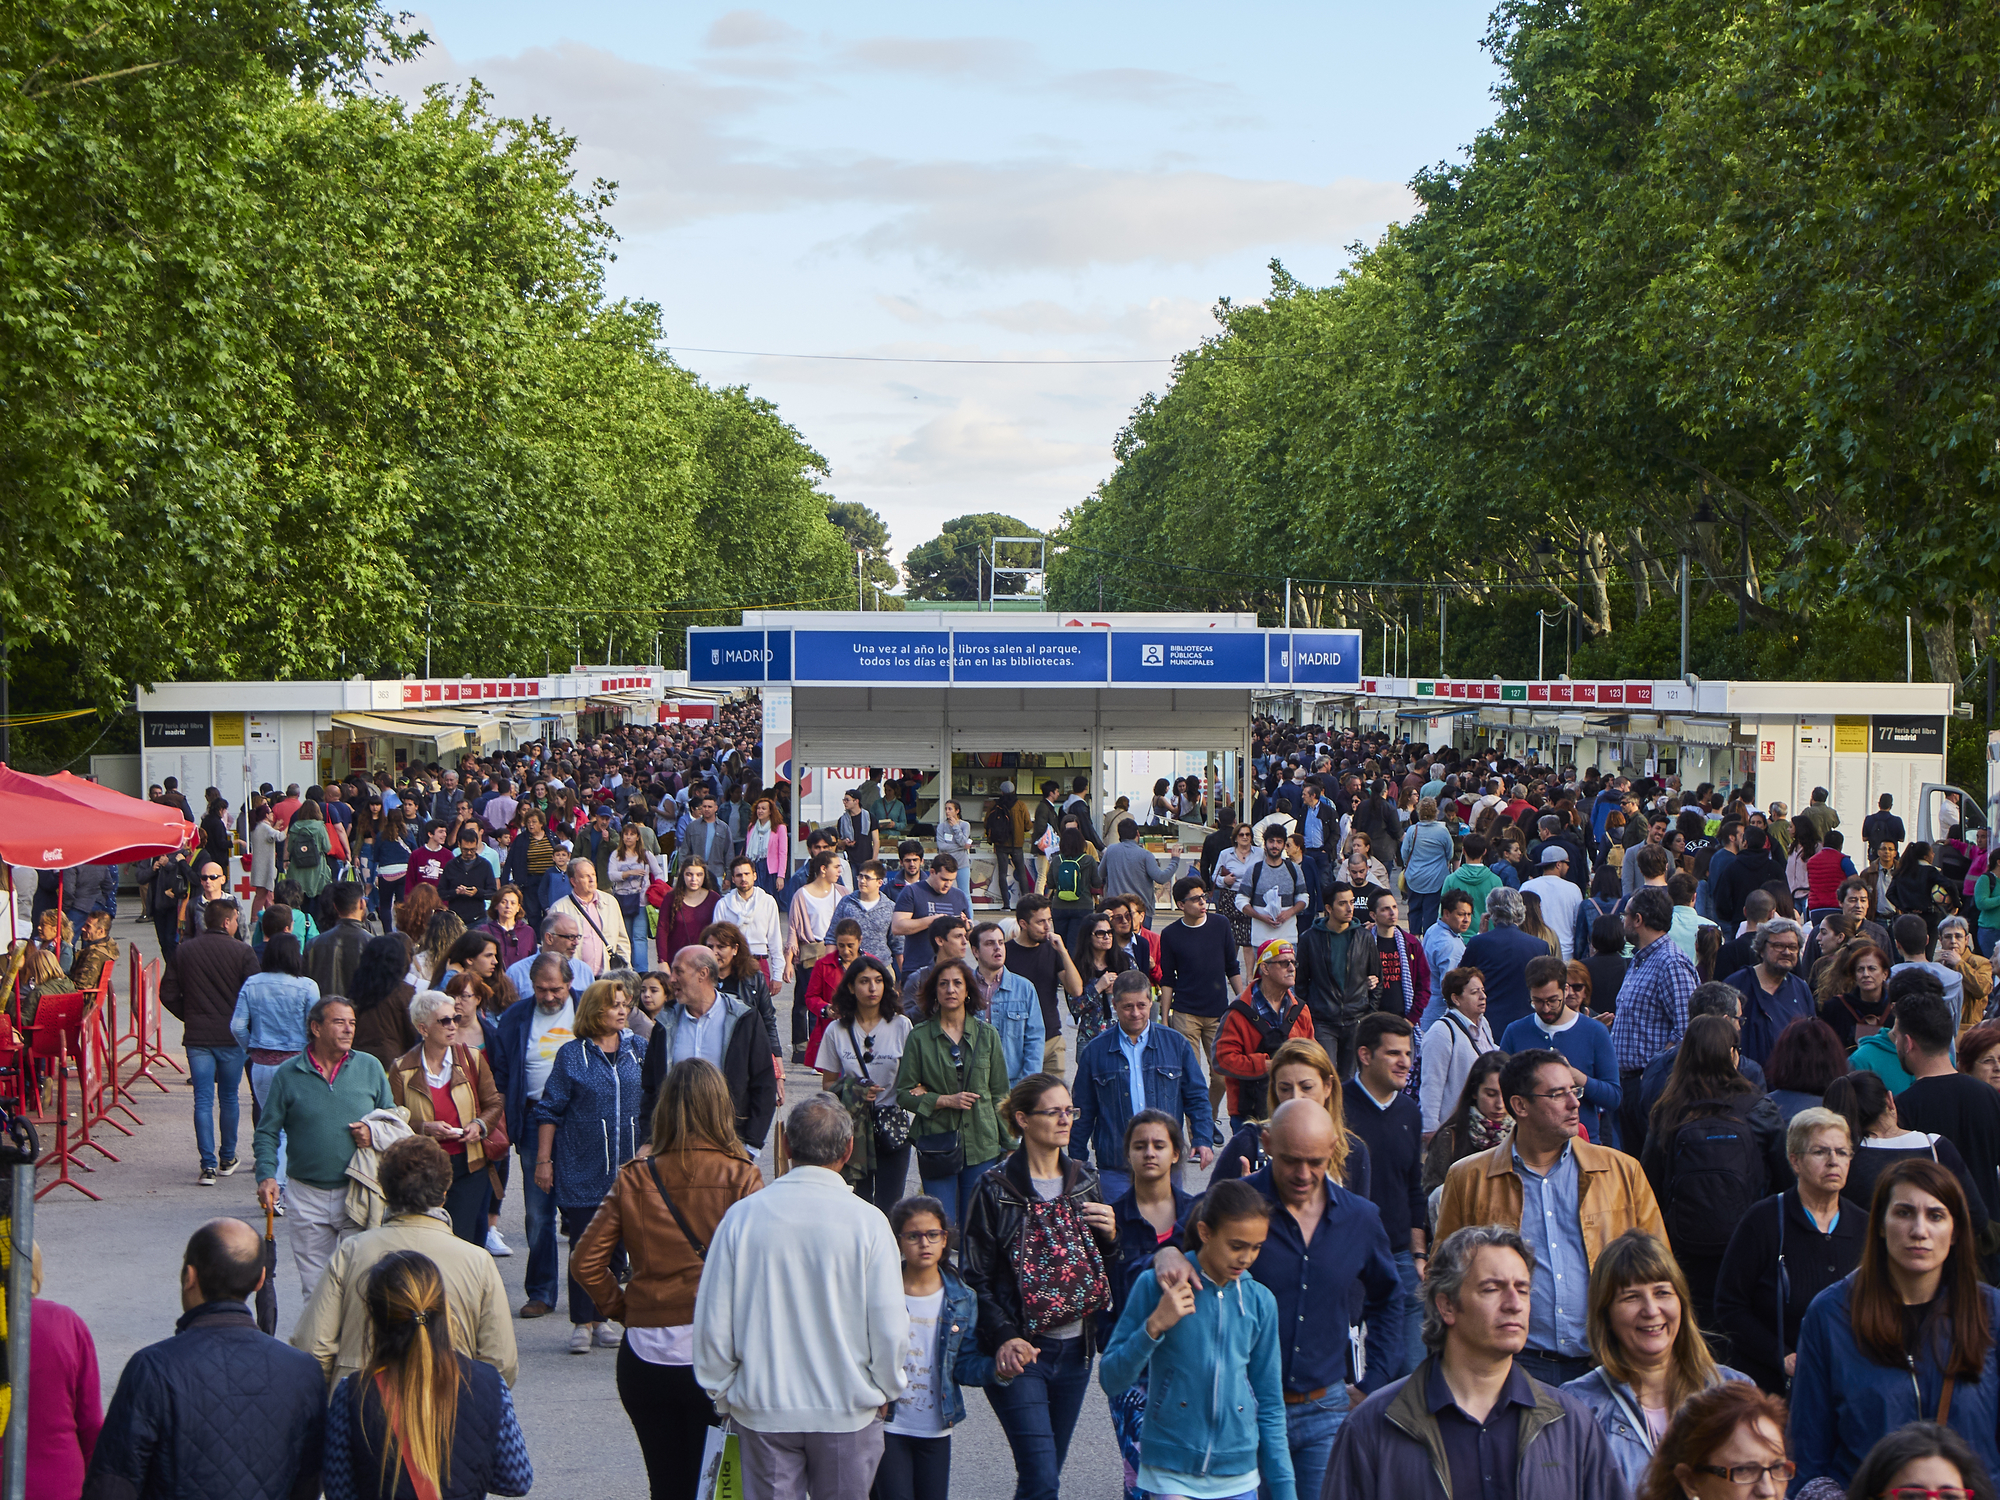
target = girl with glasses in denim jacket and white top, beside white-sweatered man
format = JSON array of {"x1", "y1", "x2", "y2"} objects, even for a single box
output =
[{"x1": 872, "y1": 1196, "x2": 994, "y2": 1500}]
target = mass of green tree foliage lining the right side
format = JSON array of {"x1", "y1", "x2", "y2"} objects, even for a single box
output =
[{"x1": 1050, "y1": 0, "x2": 2000, "y2": 682}]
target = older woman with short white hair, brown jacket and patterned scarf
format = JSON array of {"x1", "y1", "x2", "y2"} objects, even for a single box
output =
[{"x1": 388, "y1": 990, "x2": 504, "y2": 1246}]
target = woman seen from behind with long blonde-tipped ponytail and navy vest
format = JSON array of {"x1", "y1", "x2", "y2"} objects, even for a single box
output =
[{"x1": 320, "y1": 1250, "x2": 534, "y2": 1500}]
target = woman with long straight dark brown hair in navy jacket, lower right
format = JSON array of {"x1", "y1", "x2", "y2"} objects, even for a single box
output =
[{"x1": 1790, "y1": 1158, "x2": 2000, "y2": 1484}]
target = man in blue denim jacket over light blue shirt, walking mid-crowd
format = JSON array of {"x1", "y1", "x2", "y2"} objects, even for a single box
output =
[{"x1": 1070, "y1": 968, "x2": 1214, "y2": 1204}]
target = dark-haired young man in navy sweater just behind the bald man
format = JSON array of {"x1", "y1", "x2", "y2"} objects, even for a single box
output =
[{"x1": 1346, "y1": 1010, "x2": 1430, "y2": 1380}]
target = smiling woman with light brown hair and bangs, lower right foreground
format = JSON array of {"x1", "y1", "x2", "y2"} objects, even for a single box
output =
[{"x1": 1564, "y1": 1230, "x2": 1750, "y2": 1490}]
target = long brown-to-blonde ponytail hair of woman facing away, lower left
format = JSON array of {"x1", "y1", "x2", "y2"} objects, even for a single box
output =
[{"x1": 356, "y1": 1250, "x2": 464, "y2": 1494}]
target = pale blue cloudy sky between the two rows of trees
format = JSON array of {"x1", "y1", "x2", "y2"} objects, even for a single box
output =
[{"x1": 384, "y1": 0, "x2": 1494, "y2": 576}]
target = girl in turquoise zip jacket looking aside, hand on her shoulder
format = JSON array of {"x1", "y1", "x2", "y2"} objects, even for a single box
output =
[{"x1": 1098, "y1": 1180, "x2": 1298, "y2": 1500}]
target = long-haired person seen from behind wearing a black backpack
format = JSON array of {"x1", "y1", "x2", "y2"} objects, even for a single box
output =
[{"x1": 1640, "y1": 1016, "x2": 1792, "y2": 1326}]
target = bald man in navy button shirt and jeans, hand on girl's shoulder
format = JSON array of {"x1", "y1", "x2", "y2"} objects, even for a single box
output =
[{"x1": 1152, "y1": 1098, "x2": 1404, "y2": 1496}]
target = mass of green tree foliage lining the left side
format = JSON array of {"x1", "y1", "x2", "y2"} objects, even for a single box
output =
[{"x1": 0, "y1": 0, "x2": 854, "y2": 748}]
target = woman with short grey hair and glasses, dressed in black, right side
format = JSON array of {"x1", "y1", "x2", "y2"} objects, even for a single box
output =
[{"x1": 1714, "y1": 1104, "x2": 1868, "y2": 1396}]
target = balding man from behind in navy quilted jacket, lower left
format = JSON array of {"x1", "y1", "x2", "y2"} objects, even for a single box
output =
[{"x1": 84, "y1": 1218, "x2": 326, "y2": 1500}]
